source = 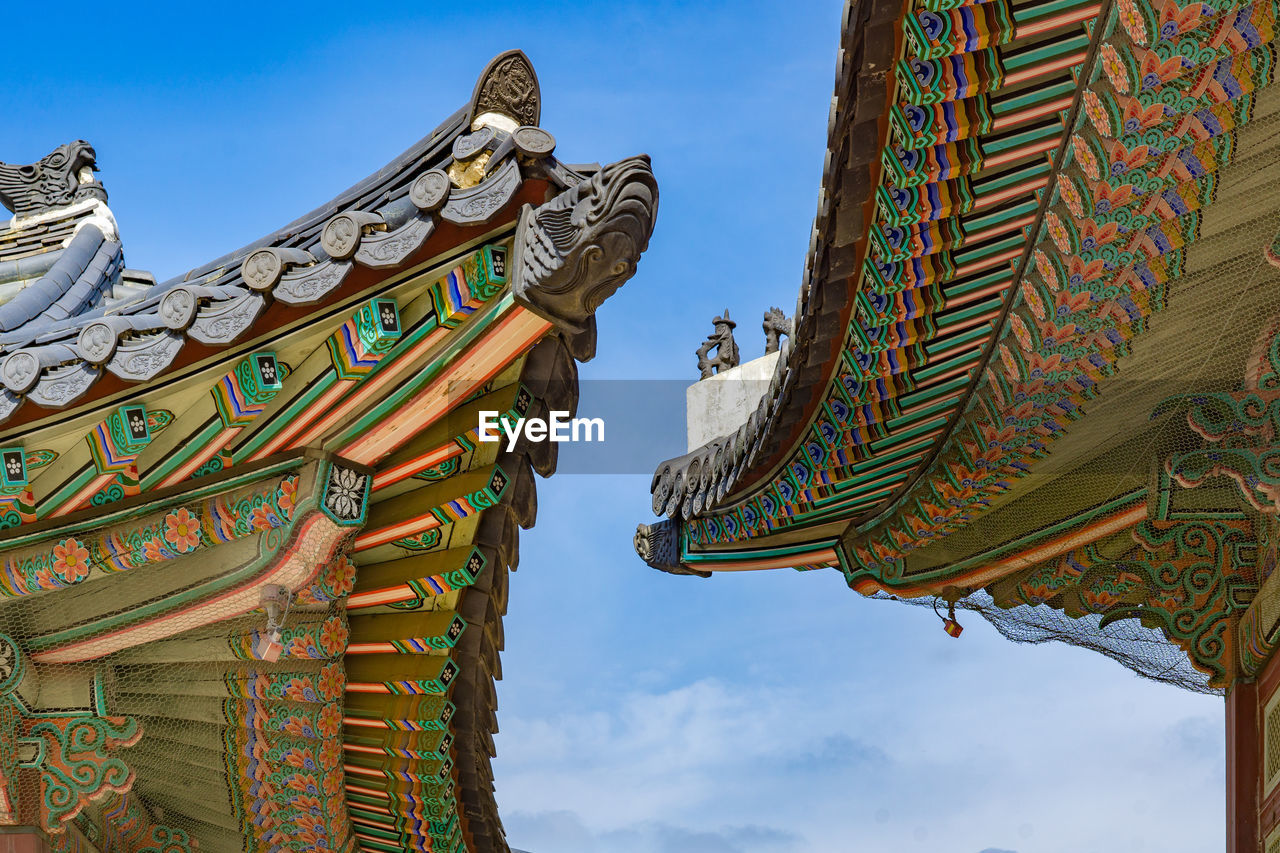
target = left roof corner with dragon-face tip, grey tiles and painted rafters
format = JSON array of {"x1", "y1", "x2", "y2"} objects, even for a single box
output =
[{"x1": 0, "y1": 51, "x2": 658, "y2": 853}]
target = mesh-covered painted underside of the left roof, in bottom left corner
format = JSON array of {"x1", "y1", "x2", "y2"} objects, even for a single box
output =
[{"x1": 0, "y1": 556, "x2": 348, "y2": 853}]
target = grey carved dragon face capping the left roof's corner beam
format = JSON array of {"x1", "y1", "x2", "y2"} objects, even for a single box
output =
[{"x1": 512, "y1": 155, "x2": 658, "y2": 332}]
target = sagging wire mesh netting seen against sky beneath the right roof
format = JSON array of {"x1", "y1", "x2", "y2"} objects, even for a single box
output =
[{"x1": 870, "y1": 590, "x2": 1224, "y2": 695}]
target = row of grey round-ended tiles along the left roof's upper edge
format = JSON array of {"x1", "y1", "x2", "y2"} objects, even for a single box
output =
[{"x1": 0, "y1": 51, "x2": 596, "y2": 424}]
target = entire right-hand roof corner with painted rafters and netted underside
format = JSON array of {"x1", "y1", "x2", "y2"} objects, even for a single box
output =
[{"x1": 636, "y1": 0, "x2": 1280, "y2": 690}]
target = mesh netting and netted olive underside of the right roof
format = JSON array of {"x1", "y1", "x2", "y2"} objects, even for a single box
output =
[{"x1": 855, "y1": 111, "x2": 1280, "y2": 695}]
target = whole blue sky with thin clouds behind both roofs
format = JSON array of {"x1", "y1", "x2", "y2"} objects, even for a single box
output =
[{"x1": 0, "y1": 0, "x2": 1224, "y2": 853}]
